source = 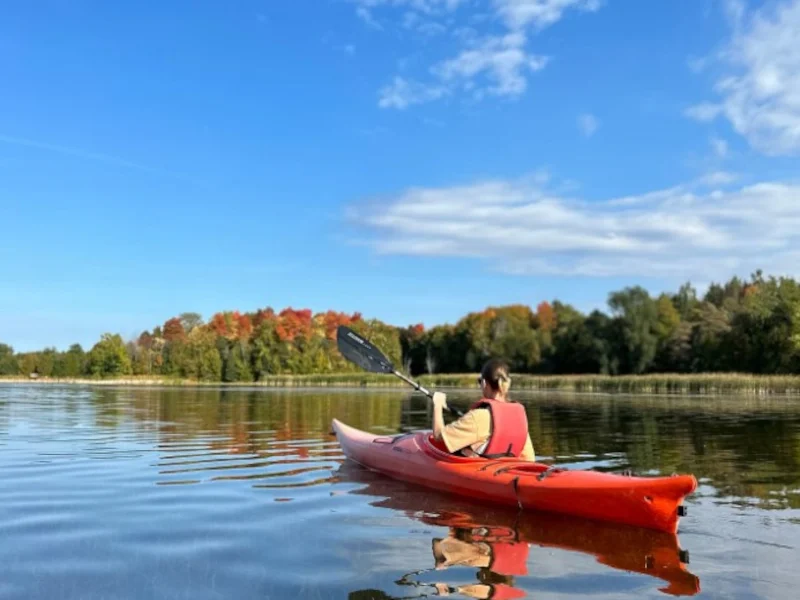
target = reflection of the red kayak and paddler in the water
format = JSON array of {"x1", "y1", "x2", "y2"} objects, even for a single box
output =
[{"x1": 337, "y1": 461, "x2": 700, "y2": 600}]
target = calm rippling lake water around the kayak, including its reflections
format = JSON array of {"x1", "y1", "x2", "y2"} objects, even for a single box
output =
[{"x1": 0, "y1": 385, "x2": 800, "y2": 600}]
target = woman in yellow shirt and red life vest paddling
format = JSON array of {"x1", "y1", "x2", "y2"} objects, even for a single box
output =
[{"x1": 433, "y1": 359, "x2": 536, "y2": 461}]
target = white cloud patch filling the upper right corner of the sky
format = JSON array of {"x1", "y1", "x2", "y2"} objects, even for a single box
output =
[{"x1": 687, "y1": 0, "x2": 800, "y2": 156}]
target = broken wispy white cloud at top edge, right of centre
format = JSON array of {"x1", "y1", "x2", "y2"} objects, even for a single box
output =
[{"x1": 351, "y1": 0, "x2": 602, "y2": 109}]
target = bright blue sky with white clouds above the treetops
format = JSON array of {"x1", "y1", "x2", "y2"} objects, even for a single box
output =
[{"x1": 0, "y1": 0, "x2": 800, "y2": 351}]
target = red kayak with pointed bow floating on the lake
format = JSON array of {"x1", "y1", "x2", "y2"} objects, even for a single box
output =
[{"x1": 333, "y1": 419, "x2": 697, "y2": 533}]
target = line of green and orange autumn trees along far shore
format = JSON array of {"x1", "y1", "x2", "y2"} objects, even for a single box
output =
[{"x1": 0, "y1": 271, "x2": 800, "y2": 382}]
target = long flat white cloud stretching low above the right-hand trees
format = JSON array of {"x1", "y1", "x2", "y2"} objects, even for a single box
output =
[{"x1": 350, "y1": 171, "x2": 800, "y2": 279}]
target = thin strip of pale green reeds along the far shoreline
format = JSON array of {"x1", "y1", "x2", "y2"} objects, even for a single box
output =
[{"x1": 0, "y1": 373, "x2": 800, "y2": 396}]
